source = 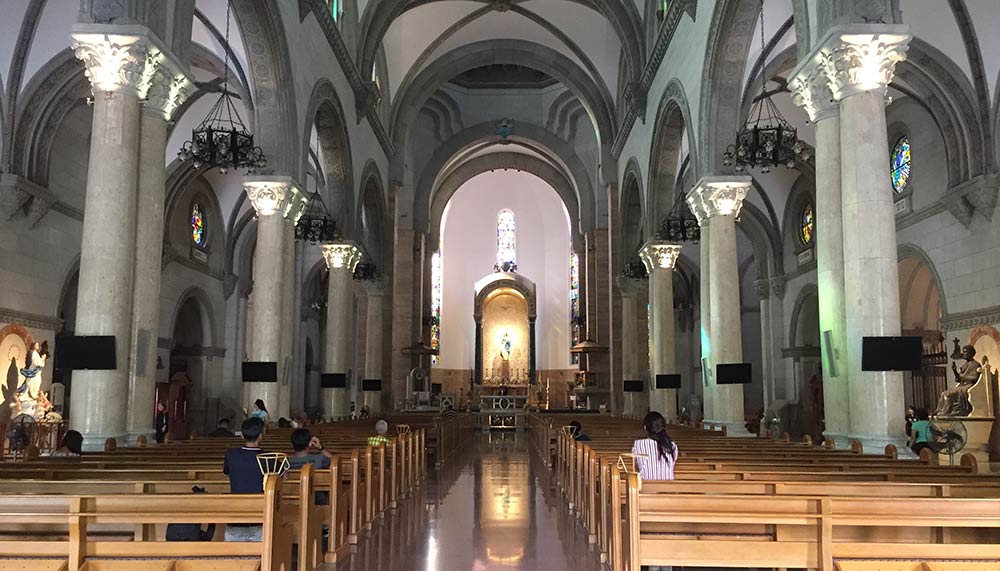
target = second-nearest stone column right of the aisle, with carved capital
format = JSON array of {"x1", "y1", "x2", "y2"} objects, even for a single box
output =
[{"x1": 687, "y1": 176, "x2": 751, "y2": 436}]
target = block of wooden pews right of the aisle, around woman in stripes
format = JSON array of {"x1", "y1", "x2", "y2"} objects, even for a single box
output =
[{"x1": 528, "y1": 414, "x2": 1000, "y2": 571}]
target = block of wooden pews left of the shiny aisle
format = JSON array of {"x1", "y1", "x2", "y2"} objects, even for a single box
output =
[{"x1": 0, "y1": 414, "x2": 472, "y2": 571}]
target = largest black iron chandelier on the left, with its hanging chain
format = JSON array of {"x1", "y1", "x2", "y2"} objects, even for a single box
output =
[{"x1": 177, "y1": 2, "x2": 267, "y2": 174}]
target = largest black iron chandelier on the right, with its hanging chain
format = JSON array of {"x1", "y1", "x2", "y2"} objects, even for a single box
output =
[{"x1": 722, "y1": 0, "x2": 809, "y2": 173}]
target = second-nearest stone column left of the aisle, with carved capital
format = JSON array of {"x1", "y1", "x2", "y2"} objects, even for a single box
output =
[{"x1": 243, "y1": 175, "x2": 306, "y2": 420}]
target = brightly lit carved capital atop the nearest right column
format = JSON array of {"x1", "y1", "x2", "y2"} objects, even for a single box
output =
[{"x1": 814, "y1": 24, "x2": 912, "y2": 101}]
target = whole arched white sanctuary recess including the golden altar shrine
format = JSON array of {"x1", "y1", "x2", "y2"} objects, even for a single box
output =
[{"x1": 428, "y1": 170, "x2": 576, "y2": 416}]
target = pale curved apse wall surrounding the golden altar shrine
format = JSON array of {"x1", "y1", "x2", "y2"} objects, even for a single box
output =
[{"x1": 436, "y1": 170, "x2": 572, "y2": 378}]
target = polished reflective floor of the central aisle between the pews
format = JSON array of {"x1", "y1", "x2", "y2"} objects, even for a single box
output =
[{"x1": 323, "y1": 433, "x2": 599, "y2": 571}]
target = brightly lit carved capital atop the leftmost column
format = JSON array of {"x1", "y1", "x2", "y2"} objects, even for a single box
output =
[{"x1": 72, "y1": 32, "x2": 148, "y2": 96}]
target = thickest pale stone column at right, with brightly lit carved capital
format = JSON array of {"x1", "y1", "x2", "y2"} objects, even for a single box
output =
[{"x1": 817, "y1": 24, "x2": 911, "y2": 451}]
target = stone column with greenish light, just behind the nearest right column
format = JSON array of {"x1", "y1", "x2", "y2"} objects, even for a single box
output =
[{"x1": 791, "y1": 54, "x2": 851, "y2": 447}]
